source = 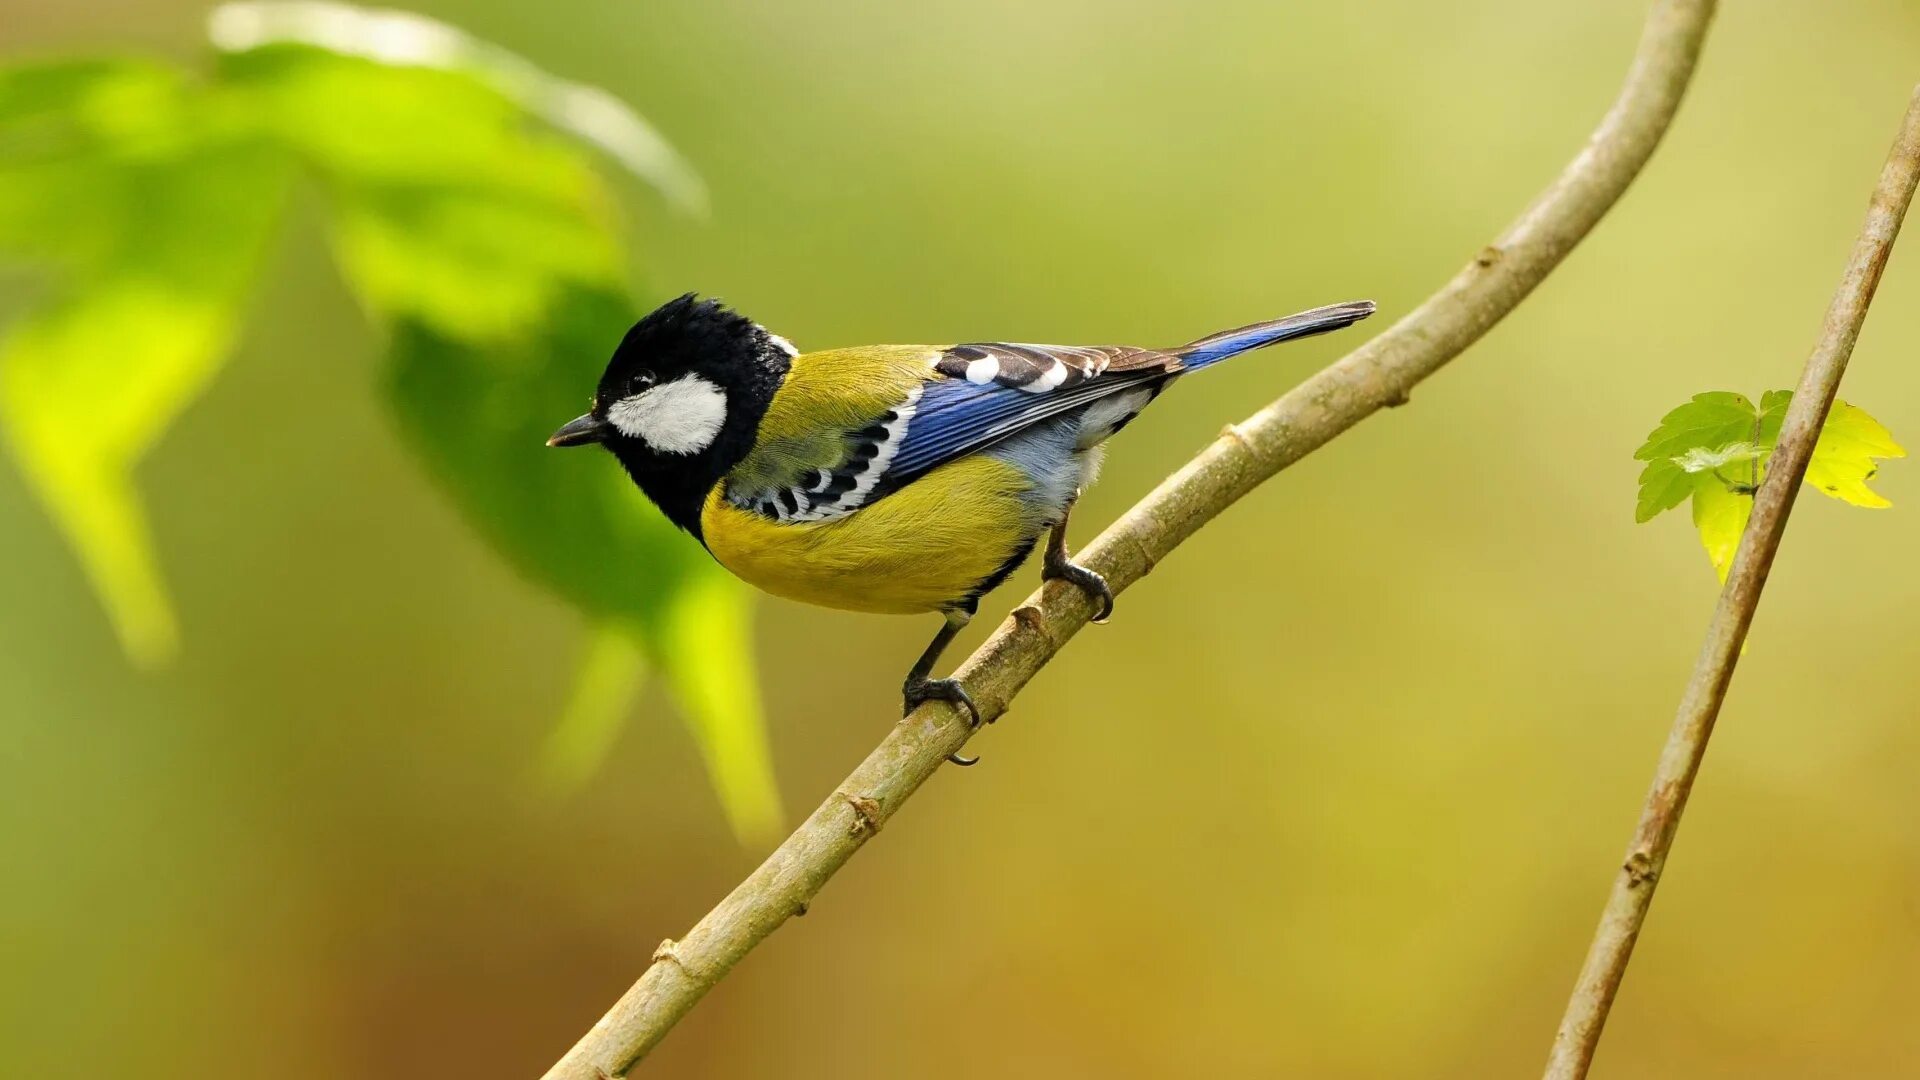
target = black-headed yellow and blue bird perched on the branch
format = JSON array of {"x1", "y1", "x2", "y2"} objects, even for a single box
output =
[{"x1": 547, "y1": 292, "x2": 1375, "y2": 765}]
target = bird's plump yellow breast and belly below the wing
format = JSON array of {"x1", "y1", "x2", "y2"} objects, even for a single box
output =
[{"x1": 701, "y1": 455, "x2": 1044, "y2": 615}]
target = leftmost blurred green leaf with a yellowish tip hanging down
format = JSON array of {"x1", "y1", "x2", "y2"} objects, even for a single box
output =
[{"x1": 0, "y1": 61, "x2": 290, "y2": 665}]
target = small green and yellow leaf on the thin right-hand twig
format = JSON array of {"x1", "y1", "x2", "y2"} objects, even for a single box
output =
[{"x1": 1634, "y1": 390, "x2": 1907, "y2": 582}]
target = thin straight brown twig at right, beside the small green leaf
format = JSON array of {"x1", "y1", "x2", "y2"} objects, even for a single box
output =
[{"x1": 1546, "y1": 88, "x2": 1920, "y2": 1080}]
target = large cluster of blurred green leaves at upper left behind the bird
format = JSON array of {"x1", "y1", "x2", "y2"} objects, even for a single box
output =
[{"x1": 0, "y1": 18, "x2": 780, "y2": 836}]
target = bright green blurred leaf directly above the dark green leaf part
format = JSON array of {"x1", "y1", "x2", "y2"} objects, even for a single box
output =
[{"x1": 227, "y1": 46, "x2": 620, "y2": 342}]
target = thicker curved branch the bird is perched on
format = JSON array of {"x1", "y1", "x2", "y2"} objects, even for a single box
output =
[{"x1": 547, "y1": 0, "x2": 1715, "y2": 1080}]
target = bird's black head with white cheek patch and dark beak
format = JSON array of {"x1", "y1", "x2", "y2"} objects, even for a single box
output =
[{"x1": 547, "y1": 292, "x2": 793, "y2": 536}]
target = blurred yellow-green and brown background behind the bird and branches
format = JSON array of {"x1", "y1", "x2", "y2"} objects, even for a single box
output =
[{"x1": 0, "y1": 0, "x2": 1920, "y2": 1080}]
